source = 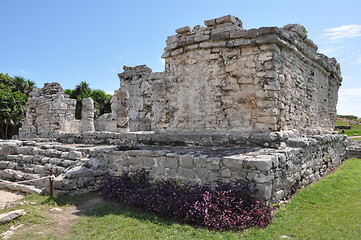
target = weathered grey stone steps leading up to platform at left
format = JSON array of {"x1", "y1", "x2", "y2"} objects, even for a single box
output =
[{"x1": 0, "y1": 139, "x2": 107, "y2": 195}]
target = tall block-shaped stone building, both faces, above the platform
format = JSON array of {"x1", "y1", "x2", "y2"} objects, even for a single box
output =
[{"x1": 162, "y1": 15, "x2": 342, "y2": 132}]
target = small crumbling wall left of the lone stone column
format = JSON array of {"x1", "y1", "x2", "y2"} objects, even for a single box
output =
[{"x1": 19, "y1": 82, "x2": 80, "y2": 137}]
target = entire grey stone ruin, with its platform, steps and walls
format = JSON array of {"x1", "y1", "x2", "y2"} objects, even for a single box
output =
[{"x1": 0, "y1": 15, "x2": 347, "y2": 203}]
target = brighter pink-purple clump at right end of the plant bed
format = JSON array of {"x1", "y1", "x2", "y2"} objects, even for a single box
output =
[{"x1": 186, "y1": 181, "x2": 272, "y2": 230}]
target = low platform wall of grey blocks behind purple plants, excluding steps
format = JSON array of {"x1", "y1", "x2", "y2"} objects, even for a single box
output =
[{"x1": 86, "y1": 131, "x2": 346, "y2": 203}]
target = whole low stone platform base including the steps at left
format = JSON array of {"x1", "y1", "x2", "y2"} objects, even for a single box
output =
[{"x1": 0, "y1": 131, "x2": 348, "y2": 203}]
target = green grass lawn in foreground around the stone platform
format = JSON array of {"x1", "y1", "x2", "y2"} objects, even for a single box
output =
[{"x1": 0, "y1": 159, "x2": 361, "y2": 240}]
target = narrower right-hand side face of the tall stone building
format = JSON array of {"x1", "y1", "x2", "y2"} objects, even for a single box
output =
[{"x1": 274, "y1": 24, "x2": 342, "y2": 129}]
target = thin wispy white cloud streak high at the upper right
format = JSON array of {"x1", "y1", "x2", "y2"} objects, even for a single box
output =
[{"x1": 324, "y1": 24, "x2": 361, "y2": 41}]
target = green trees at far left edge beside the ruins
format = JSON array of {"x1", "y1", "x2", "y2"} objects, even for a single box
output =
[{"x1": 0, "y1": 73, "x2": 35, "y2": 139}]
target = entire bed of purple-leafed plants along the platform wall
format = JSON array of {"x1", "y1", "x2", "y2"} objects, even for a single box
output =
[{"x1": 102, "y1": 169, "x2": 272, "y2": 230}]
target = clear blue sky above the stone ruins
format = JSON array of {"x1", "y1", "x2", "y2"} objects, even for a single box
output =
[{"x1": 0, "y1": 0, "x2": 361, "y2": 117}]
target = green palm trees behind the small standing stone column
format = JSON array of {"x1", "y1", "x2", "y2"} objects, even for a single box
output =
[{"x1": 64, "y1": 81, "x2": 112, "y2": 119}]
